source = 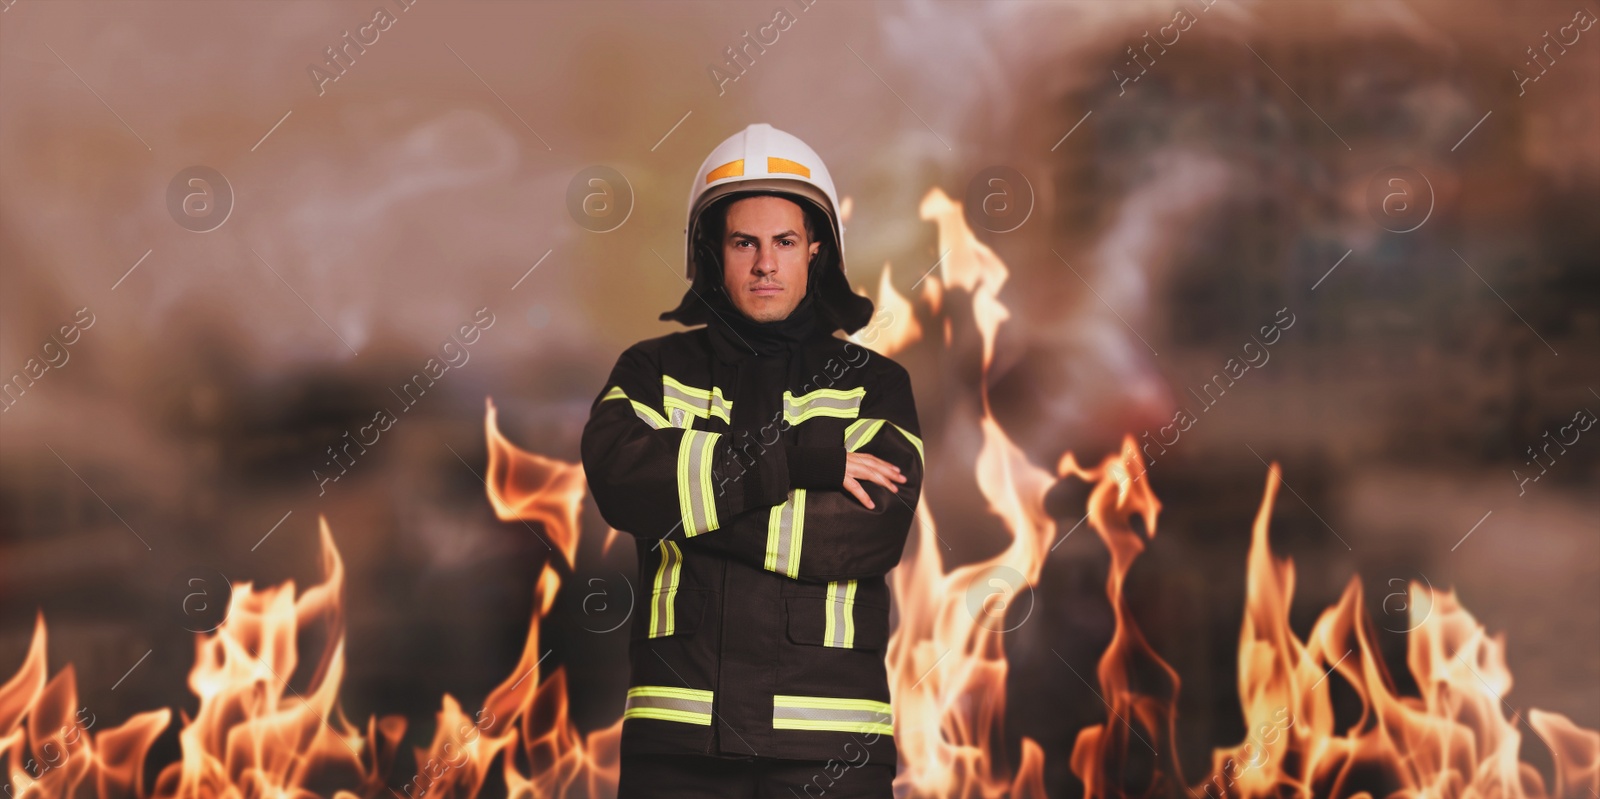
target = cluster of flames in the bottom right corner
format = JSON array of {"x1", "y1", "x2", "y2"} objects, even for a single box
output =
[{"x1": 1171, "y1": 463, "x2": 1600, "y2": 797}]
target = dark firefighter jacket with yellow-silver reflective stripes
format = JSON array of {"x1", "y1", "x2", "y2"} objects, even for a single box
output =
[{"x1": 582, "y1": 315, "x2": 923, "y2": 765}]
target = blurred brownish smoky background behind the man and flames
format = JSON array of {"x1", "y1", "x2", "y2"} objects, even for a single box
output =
[{"x1": 0, "y1": 0, "x2": 1600, "y2": 796}]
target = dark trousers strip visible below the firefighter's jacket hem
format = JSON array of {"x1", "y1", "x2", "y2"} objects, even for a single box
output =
[{"x1": 616, "y1": 754, "x2": 894, "y2": 799}]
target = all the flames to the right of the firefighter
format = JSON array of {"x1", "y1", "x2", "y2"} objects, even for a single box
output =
[{"x1": 888, "y1": 189, "x2": 1600, "y2": 799}]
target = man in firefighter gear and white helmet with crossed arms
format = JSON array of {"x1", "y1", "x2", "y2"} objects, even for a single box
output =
[{"x1": 582, "y1": 125, "x2": 923, "y2": 799}]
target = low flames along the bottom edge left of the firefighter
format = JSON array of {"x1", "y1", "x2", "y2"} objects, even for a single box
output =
[{"x1": 0, "y1": 512, "x2": 621, "y2": 799}]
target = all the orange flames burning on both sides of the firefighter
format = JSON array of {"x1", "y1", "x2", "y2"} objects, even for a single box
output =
[{"x1": 0, "y1": 189, "x2": 1600, "y2": 799}]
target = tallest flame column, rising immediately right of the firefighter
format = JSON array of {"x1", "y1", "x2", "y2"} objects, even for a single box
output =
[{"x1": 886, "y1": 189, "x2": 1056, "y2": 797}]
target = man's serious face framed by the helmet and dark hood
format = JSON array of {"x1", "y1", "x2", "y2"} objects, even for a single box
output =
[{"x1": 722, "y1": 195, "x2": 821, "y2": 322}]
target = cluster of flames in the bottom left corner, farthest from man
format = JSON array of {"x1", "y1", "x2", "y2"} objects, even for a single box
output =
[{"x1": 0, "y1": 522, "x2": 405, "y2": 797}]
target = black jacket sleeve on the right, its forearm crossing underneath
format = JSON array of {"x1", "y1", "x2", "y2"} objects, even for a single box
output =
[{"x1": 688, "y1": 365, "x2": 925, "y2": 583}]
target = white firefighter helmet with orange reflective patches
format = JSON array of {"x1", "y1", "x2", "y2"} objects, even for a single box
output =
[{"x1": 683, "y1": 122, "x2": 845, "y2": 282}]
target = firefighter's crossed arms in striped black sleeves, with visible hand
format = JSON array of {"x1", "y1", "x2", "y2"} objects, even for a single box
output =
[{"x1": 582, "y1": 347, "x2": 923, "y2": 581}]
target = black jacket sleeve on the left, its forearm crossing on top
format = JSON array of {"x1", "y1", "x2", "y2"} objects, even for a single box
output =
[{"x1": 579, "y1": 344, "x2": 806, "y2": 541}]
